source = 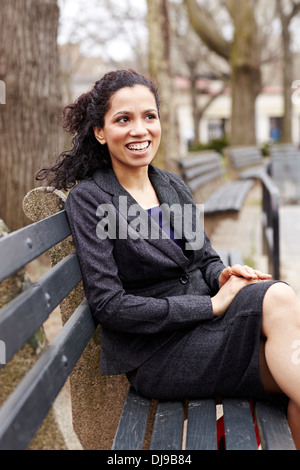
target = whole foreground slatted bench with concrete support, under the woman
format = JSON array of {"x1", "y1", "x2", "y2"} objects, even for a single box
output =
[{"x1": 0, "y1": 188, "x2": 295, "y2": 450}]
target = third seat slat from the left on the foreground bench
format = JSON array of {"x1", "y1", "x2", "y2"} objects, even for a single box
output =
[{"x1": 186, "y1": 399, "x2": 217, "y2": 450}]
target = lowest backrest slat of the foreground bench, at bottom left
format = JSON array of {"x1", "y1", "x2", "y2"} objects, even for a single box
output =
[{"x1": 0, "y1": 300, "x2": 95, "y2": 450}]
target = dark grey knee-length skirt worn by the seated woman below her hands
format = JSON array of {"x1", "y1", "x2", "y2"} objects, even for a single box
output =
[{"x1": 127, "y1": 281, "x2": 284, "y2": 400}]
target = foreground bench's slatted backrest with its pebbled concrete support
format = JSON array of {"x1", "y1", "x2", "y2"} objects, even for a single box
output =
[{"x1": 0, "y1": 188, "x2": 128, "y2": 449}]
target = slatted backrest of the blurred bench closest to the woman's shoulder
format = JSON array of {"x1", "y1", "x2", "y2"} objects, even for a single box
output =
[{"x1": 178, "y1": 151, "x2": 225, "y2": 192}]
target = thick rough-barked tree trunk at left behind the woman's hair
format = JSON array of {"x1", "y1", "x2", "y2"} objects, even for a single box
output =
[{"x1": 0, "y1": 0, "x2": 61, "y2": 230}]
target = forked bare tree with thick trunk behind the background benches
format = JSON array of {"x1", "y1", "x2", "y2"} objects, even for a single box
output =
[{"x1": 184, "y1": 0, "x2": 262, "y2": 145}]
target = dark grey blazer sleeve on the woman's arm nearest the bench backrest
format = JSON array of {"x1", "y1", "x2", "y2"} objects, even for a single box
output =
[{"x1": 66, "y1": 183, "x2": 217, "y2": 334}]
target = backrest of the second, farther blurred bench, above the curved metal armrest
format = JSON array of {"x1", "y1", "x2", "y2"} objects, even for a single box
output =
[{"x1": 225, "y1": 146, "x2": 265, "y2": 179}]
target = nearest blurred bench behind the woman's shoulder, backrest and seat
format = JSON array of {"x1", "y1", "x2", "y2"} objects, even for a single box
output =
[{"x1": 178, "y1": 151, "x2": 253, "y2": 236}]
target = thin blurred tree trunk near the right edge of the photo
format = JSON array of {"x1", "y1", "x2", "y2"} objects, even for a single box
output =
[{"x1": 276, "y1": 0, "x2": 300, "y2": 143}]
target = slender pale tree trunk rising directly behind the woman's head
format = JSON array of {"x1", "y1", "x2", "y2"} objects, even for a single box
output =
[{"x1": 147, "y1": 0, "x2": 178, "y2": 168}]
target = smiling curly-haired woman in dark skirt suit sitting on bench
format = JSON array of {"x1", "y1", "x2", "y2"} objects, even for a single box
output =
[{"x1": 37, "y1": 70, "x2": 300, "y2": 448}]
